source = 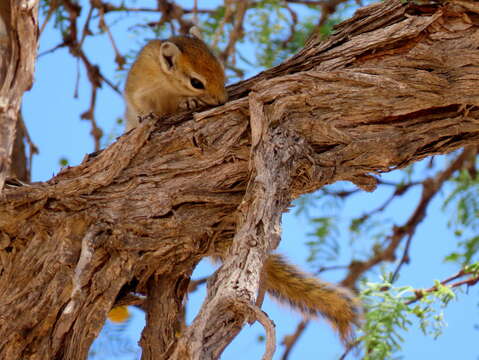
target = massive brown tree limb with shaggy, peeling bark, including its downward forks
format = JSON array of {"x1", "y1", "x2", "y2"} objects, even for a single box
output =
[{"x1": 0, "y1": 1, "x2": 479, "y2": 359}]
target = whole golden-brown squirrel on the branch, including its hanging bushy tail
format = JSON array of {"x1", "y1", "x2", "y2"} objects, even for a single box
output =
[{"x1": 119, "y1": 28, "x2": 361, "y2": 342}]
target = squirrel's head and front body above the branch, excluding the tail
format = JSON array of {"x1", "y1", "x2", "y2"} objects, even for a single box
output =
[{"x1": 124, "y1": 26, "x2": 228, "y2": 131}]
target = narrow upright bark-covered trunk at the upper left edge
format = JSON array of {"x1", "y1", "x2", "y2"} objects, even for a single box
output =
[{"x1": 0, "y1": 0, "x2": 38, "y2": 192}]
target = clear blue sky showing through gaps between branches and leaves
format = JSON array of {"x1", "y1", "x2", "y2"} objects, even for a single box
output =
[{"x1": 23, "y1": 1, "x2": 479, "y2": 360}]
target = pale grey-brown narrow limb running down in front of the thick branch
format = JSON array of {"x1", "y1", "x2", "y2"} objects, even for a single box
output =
[{"x1": 173, "y1": 93, "x2": 307, "y2": 359}]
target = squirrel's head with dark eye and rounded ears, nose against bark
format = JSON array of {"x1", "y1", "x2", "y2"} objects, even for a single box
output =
[{"x1": 159, "y1": 28, "x2": 228, "y2": 105}]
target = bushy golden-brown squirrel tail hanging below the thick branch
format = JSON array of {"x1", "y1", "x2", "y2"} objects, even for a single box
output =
[{"x1": 263, "y1": 254, "x2": 361, "y2": 343}]
